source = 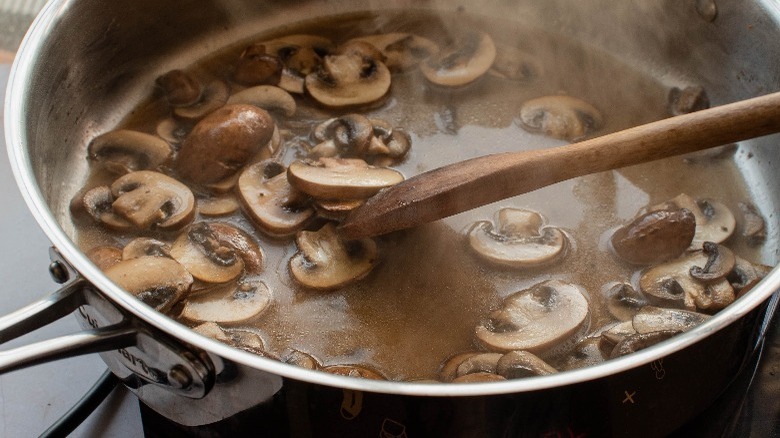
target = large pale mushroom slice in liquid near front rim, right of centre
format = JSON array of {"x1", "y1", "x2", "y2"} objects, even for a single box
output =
[{"x1": 476, "y1": 280, "x2": 590, "y2": 356}]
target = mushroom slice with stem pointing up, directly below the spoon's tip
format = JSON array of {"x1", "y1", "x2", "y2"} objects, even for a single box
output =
[{"x1": 290, "y1": 223, "x2": 377, "y2": 290}]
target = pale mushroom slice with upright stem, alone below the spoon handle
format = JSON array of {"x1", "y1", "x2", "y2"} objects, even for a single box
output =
[{"x1": 468, "y1": 208, "x2": 568, "y2": 268}]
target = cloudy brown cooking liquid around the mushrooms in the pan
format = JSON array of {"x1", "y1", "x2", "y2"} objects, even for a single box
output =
[{"x1": 80, "y1": 13, "x2": 759, "y2": 380}]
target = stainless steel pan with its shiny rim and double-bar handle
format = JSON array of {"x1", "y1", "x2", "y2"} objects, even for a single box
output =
[{"x1": 0, "y1": 0, "x2": 780, "y2": 433}]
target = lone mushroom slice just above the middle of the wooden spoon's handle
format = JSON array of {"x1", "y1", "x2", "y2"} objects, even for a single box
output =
[{"x1": 520, "y1": 95, "x2": 603, "y2": 141}]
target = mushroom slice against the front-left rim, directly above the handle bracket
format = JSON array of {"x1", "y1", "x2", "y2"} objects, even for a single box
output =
[{"x1": 105, "y1": 257, "x2": 192, "y2": 312}]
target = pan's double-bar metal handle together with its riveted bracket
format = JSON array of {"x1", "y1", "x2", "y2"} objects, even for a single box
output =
[{"x1": 0, "y1": 248, "x2": 215, "y2": 399}]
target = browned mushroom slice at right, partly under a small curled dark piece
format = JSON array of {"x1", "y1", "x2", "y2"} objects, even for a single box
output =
[{"x1": 639, "y1": 250, "x2": 735, "y2": 312}]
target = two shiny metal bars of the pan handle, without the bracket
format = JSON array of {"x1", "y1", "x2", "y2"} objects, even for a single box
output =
[{"x1": 0, "y1": 278, "x2": 137, "y2": 374}]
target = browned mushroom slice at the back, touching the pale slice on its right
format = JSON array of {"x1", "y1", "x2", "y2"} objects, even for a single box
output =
[{"x1": 351, "y1": 32, "x2": 439, "y2": 71}]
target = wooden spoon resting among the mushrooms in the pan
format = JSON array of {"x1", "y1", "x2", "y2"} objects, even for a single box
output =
[{"x1": 340, "y1": 92, "x2": 780, "y2": 239}]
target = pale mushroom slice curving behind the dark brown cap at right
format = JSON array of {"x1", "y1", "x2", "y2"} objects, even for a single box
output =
[{"x1": 651, "y1": 193, "x2": 737, "y2": 249}]
